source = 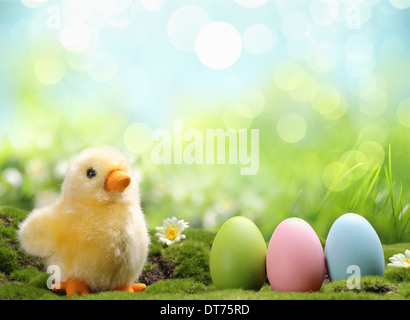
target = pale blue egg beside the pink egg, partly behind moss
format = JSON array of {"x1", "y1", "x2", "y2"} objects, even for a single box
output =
[{"x1": 325, "y1": 213, "x2": 384, "y2": 281}]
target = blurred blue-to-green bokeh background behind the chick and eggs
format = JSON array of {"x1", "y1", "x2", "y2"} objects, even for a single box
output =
[{"x1": 0, "y1": 0, "x2": 410, "y2": 242}]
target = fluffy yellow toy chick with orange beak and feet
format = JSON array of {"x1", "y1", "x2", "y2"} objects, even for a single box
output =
[{"x1": 19, "y1": 147, "x2": 150, "y2": 296}]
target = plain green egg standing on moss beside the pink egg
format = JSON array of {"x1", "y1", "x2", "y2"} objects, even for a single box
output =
[{"x1": 209, "y1": 217, "x2": 267, "y2": 290}]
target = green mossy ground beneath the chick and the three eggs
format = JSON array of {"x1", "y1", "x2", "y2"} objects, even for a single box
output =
[{"x1": 0, "y1": 207, "x2": 410, "y2": 300}]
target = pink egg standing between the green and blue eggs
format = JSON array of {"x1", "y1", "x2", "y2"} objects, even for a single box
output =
[{"x1": 266, "y1": 218, "x2": 325, "y2": 292}]
